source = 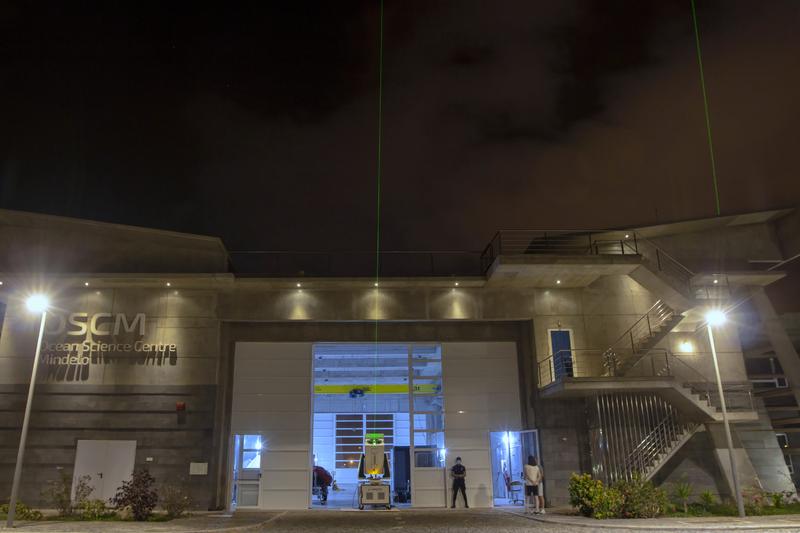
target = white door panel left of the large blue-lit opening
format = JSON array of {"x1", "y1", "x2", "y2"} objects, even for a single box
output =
[{"x1": 231, "y1": 342, "x2": 311, "y2": 509}]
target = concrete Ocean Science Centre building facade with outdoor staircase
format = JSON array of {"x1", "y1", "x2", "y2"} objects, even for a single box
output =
[{"x1": 0, "y1": 206, "x2": 800, "y2": 509}]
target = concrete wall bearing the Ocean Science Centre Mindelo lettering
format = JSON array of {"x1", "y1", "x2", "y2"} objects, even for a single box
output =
[{"x1": 0, "y1": 289, "x2": 219, "y2": 509}]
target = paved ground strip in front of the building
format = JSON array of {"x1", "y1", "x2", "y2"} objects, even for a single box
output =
[{"x1": 4, "y1": 509, "x2": 800, "y2": 533}]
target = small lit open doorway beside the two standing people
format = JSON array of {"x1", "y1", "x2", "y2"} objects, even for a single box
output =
[{"x1": 489, "y1": 429, "x2": 542, "y2": 507}]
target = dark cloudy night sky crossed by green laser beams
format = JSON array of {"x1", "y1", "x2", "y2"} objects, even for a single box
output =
[{"x1": 0, "y1": 0, "x2": 800, "y2": 250}]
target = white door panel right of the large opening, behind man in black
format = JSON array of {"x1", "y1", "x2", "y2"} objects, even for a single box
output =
[{"x1": 442, "y1": 342, "x2": 523, "y2": 507}]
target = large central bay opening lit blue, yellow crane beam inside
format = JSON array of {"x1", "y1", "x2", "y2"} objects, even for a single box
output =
[{"x1": 311, "y1": 343, "x2": 445, "y2": 509}]
